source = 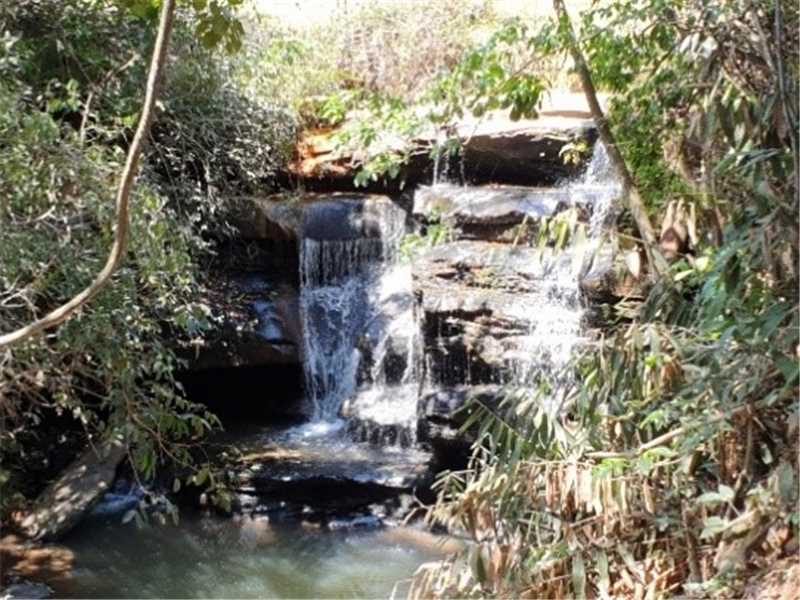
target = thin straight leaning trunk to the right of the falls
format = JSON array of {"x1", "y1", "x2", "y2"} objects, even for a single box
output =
[{"x1": 553, "y1": 0, "x2": 667, "y2": 275}]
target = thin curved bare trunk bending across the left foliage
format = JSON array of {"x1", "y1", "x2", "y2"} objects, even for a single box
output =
[{"x1": 0, "y1": 0, "x2": 176, "y2": 350}]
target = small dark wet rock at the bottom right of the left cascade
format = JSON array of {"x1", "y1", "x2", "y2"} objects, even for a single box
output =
[{"x1": 417, "y1": 385, "x2": 503, "y2": 468}]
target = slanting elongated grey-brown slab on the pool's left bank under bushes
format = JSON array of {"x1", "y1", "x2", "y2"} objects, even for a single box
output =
[{"x1": 18, "y1": 442, "x2": 126, "y2": 540}]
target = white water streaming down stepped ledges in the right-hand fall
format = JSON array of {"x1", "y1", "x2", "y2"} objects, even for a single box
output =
[{"x1": 422, "y1": 143, "x2": 621, "y2": 410}]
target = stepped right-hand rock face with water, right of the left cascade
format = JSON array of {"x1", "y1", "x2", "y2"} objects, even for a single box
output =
[{"x1": 413, "y1": 161, "x2": 618, "y2": 467}]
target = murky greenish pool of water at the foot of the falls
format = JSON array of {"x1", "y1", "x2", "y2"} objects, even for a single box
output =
[{"x1": 57, "y1": 514, "x2": 442, "y2": 598}]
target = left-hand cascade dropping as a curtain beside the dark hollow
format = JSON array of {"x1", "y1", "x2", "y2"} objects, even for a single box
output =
[{"x1": 300, "y1": 198, "x2": 419, "y2": 444}]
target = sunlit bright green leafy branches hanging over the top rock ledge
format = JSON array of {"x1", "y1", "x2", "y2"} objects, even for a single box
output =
[{"x1": 328, "y1": 21, "x2": 545, "y2": 186}]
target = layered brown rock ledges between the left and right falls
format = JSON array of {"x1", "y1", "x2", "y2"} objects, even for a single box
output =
[{"x1": 414, "y1": 241, "x2": 580, "y2": 385}]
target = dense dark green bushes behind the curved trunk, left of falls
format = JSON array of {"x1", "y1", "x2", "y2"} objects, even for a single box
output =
[{"x1": 0, "y1": 0, "x2": 294, "y2": 512}]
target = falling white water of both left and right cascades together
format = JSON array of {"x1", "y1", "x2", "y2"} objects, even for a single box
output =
[{"x1": 300, "y1": 144, "x2": 620, "y2": 446}]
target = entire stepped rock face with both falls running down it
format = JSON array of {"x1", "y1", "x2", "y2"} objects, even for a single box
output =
[{"x1": 184, "y1": 117, "x2": 617, "y2": 514}]
